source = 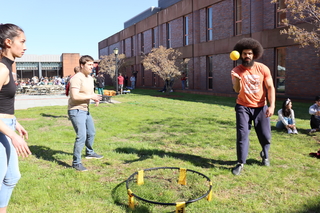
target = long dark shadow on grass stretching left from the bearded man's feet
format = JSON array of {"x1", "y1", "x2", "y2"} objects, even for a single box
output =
[{"x1": 115, "y1": 147, "x2": 236, "y2": 170}]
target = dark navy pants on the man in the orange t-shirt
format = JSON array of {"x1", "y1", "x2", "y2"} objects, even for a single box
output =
[{"x1": 235, "y1": 104, "x2": 271, "y2": 164}]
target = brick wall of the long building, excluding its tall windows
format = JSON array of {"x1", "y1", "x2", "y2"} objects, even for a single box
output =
[{"x1": 99, "y1": 0, "x2": 320, "y2": 98}]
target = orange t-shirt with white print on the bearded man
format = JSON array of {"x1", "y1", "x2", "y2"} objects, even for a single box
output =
[{"x1": 232, "y1": 62, "x2": 271, "y2": 108}]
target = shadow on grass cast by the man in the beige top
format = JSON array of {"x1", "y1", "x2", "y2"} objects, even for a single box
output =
[{"x1": 29, "y1": 146, "x2": 72, "y2": 168}]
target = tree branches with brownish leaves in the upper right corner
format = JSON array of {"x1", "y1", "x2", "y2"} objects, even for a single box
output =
[{"x1": 271, "y1": 0, "x2": 320, "y2": 52}]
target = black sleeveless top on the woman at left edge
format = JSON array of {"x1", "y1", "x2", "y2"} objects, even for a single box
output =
[{"x1": 0, "y1": 57, "x2": 17, "y2": 115}]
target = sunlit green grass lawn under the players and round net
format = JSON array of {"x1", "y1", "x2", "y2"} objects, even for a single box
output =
[{"x1": 8, "y1": 89, "x2": 320, "y2": 213}]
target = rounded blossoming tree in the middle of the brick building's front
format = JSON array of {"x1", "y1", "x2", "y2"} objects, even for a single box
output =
[{"x1": 142, "y1": 46, "x2": 190, "y2": 93}]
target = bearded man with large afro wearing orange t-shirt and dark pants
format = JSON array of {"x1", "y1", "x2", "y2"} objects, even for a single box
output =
[{"x1": 231, "y1": 38, "x2": 275, "y2": 175}]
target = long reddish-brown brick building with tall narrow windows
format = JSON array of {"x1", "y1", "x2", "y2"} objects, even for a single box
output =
[{"x1": 98, "y1": 0, "x2": 320, "y2": 99}]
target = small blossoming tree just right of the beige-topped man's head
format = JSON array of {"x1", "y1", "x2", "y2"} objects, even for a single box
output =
[{"x1": 99, "y1": 53, "x2": 126, "y2": 83}]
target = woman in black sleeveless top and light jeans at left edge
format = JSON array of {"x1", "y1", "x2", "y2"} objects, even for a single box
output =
[{"x1": 0, "y1": 24, "x2": 31, "y2": 213}]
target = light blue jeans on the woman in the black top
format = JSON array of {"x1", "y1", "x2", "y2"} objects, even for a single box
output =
[{"x1": 0, "y1": 118, "x2": 21, "y2": 208}]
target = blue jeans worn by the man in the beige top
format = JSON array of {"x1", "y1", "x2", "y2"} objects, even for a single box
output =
[{"x1": 68, "y1": 109, "x2": 96, "y2": 165}]
